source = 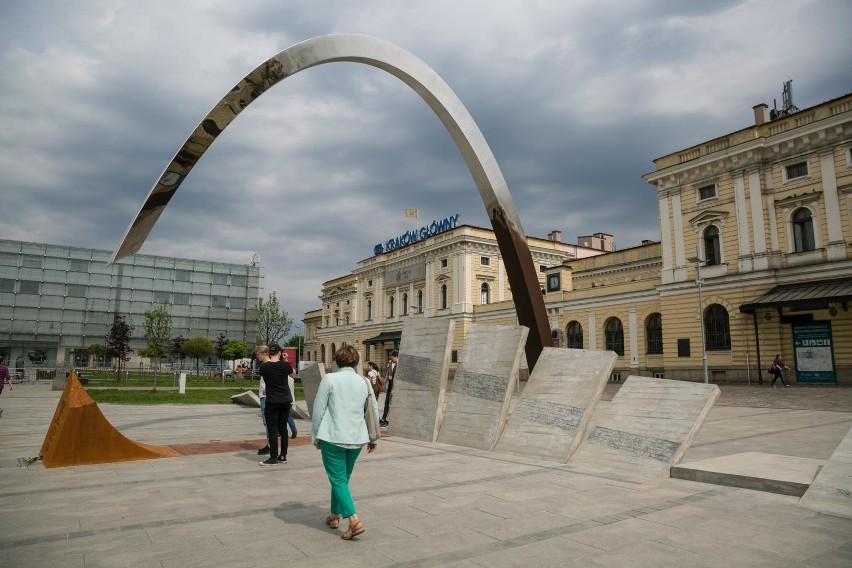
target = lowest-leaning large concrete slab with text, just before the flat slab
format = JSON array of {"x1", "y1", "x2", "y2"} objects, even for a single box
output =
[{"x1": 569, "y1": 376, "x2": 719, "y2": 477}]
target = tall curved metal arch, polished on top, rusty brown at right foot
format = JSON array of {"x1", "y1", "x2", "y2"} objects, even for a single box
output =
[{"x1": 112, "y1": 34, "x2": 551, "y2": 368}]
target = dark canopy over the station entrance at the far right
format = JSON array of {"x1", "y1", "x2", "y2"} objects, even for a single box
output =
[{"x1": 740, "y1": 278, "x2": 852, "y2": 314}]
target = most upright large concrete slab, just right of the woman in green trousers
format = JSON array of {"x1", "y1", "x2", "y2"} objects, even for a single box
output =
[{"x1": 391, "y1": 318, "x2": 455, "y2": 442}]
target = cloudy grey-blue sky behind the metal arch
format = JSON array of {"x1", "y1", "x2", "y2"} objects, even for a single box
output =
[{"x1": 0, "y1": 0, "x2": 852, "y2": 328}]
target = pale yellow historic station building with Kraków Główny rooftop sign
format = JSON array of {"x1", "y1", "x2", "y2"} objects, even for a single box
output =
[{"x1": 304, "y1": 94, "x2": 852, "y2": 384}]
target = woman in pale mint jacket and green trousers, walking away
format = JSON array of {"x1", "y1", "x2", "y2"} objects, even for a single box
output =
[{"x1": 311, "y1": 345, "x2": 380, "y2": 540}]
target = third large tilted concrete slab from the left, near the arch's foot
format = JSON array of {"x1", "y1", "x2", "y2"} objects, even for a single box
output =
[{"x1": 495, "y1": 347, "x2": 617, "y2": 463}]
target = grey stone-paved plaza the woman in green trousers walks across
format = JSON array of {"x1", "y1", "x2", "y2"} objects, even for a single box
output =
[{"x1": 0, "y1": 384, "x2": 852, "y2": 568}]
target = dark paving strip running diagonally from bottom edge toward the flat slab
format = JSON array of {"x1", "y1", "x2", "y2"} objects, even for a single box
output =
[{"x1": 386, "y1": 488, "x2": 734, "y2": 568}]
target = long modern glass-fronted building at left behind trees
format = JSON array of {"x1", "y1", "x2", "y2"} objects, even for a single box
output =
[{"x1": 0, "y1": 239, "x2": 261, "y2": 366}]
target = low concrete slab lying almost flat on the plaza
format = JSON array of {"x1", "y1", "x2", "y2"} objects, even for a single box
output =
[{"x1": 671, "y1": 452, "x2": 825, "y2": 497}]
